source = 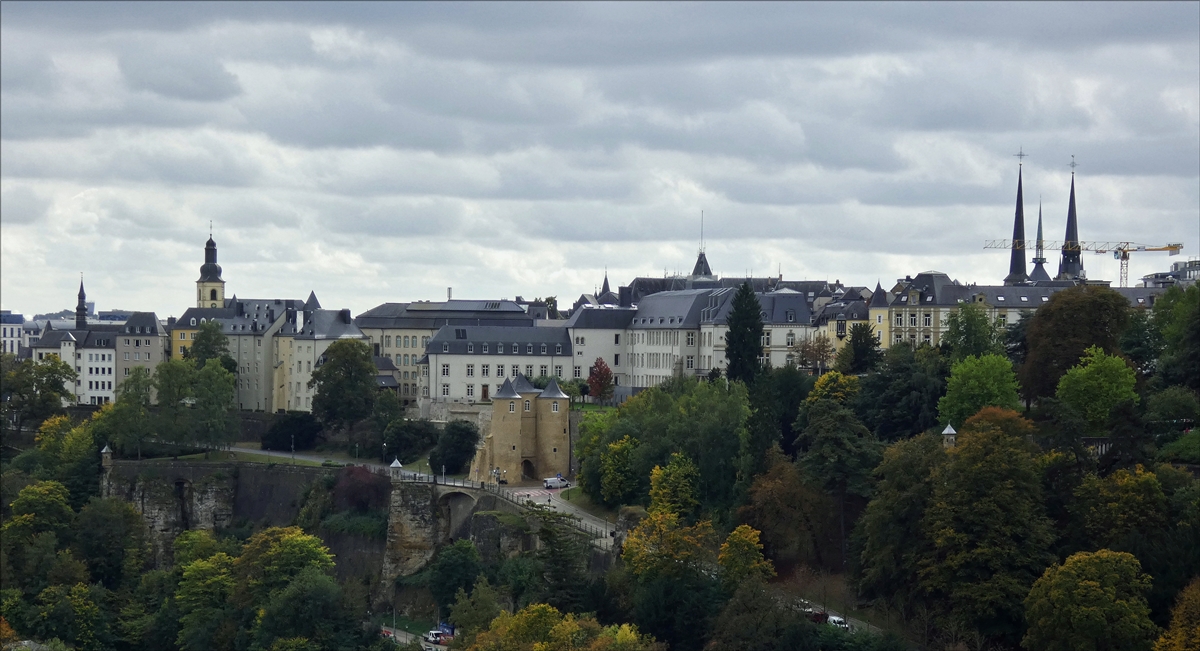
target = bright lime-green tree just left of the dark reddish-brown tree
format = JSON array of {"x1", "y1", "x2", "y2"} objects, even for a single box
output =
[{"x1": 937, "y1": 354, "x2": 1020, "y2": 425}]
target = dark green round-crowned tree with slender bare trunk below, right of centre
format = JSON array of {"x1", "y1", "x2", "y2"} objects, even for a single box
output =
[{"x1": 797, "y1": 400, "x2": 882, "y2": 563}]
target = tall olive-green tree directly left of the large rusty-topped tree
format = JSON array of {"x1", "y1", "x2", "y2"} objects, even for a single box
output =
[{"x1": 852, "y1": 434, "x2": 946, "y2": 615}]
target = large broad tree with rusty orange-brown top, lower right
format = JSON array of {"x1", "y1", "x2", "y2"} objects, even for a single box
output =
[{"x1": 920, "y1": 417, "x2": 1054, "y2": 644}]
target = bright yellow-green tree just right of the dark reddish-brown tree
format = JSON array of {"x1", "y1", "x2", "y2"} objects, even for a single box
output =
[{"x1": 1055, "y1": 346, "x2": 1138, "y2": 431}]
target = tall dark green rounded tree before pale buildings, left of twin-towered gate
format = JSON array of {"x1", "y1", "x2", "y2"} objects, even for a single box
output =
[{"x1": 308, "y1": 339, "x2": 376, "y2": 437}]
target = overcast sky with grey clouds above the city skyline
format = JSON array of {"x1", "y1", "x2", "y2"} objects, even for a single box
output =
[{"x1": 0, "y1": 1, "x2": 1200, "y2": 317}]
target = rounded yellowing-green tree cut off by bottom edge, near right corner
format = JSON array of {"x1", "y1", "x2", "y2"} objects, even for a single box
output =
[{"x1": 1021, "y1": 549, "x2": 1158, "y2": 651}]
